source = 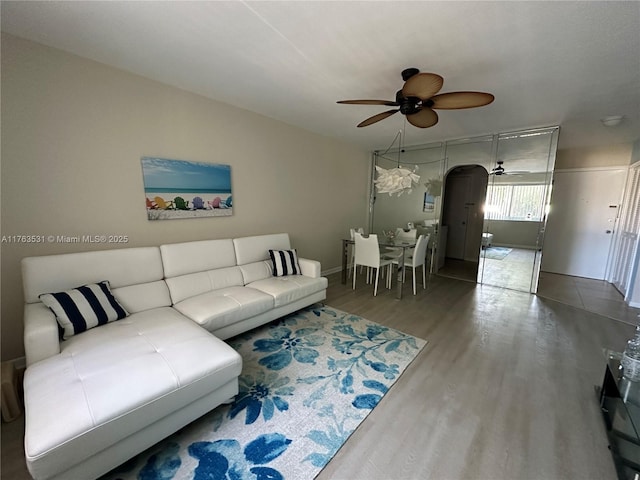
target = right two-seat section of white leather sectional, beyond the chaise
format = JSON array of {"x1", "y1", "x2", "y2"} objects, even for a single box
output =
[{"x1": 160, "y1": 234, "x2": 327, "y2": 339}]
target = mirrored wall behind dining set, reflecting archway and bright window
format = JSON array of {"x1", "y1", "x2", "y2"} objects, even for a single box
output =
[{"x1": 369, "y1": 127, "x2": 558, "y2": 292}]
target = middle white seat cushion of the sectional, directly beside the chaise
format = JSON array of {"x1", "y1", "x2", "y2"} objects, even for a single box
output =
[{"x1": 174, "y1": 287, "x2": 274, "y2": 331}]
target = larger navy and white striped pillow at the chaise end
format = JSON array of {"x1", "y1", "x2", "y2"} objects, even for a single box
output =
[{"x1": 39, "y1": 280, "x2": 129, "y2": 340}]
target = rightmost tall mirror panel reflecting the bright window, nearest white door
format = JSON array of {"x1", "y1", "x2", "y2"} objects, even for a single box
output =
[{"x1": 478, "y1": 128, "x2": 558, "y2": 293}]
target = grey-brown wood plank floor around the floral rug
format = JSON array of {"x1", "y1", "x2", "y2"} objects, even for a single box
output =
[{"x1": 1, "y1": 274, "x2": 633, "y2": 480}]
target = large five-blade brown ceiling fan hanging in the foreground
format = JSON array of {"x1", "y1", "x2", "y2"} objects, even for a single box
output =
[{"x1": 338, "y1": 68, "x2": 495, "y2": 128}]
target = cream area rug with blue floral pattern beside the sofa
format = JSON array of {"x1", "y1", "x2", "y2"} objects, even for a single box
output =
[{"x1": 103, "y1": 304, "x2": 427, "y2": 480}]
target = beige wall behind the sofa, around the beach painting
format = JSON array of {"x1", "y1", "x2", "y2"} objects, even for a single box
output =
[{"x1": 1, "y1": 35, "x2": 370, "y2": 360}]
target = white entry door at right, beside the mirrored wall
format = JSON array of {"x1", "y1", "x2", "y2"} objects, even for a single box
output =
[{"x1": 541, "y1": 168, "x2": 627, "y2": 280}]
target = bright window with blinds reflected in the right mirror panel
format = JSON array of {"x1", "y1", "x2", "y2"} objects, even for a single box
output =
[{"x1": 485, "y1": 184, "x2": 545, "y2": 222}]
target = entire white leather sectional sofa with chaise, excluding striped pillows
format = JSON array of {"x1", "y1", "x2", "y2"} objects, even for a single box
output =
[{"x1": 22, "y1": 234, "x2": 327, "y2": 480}]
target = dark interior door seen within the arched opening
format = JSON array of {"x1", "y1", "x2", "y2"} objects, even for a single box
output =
[{"x1": 443, "y1": 174, "x2": 471, "y2": 260}]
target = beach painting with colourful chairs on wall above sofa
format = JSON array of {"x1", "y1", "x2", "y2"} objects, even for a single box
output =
[{"x1": 142, "y1": 157, "x2": 233, "y2": 220}]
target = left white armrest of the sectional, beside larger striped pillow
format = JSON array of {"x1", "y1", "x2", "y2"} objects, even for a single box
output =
[{"x1": 24, "y1": 303, "x2": 60, "y2": 367}]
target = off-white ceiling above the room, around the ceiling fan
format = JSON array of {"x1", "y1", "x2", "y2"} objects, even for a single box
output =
[{"x1": 1, "y1": 1, "x2": 640, "y2": 150}]
